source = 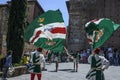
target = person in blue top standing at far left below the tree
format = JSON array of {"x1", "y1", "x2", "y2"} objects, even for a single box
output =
[{"x1": 2, "y1": 50, "x2": 13, "y2": 80}]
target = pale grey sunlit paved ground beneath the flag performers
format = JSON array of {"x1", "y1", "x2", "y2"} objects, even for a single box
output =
[{"x1": 0, "y1": 63, "x2": 120, "y2": 80}]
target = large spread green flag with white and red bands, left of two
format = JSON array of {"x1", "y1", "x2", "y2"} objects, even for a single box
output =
[{"x1": 25, "y1": 10, "x2": 66, "y2": 51}]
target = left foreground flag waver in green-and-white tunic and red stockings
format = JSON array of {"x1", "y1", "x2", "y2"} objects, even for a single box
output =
[{"x1": 28, "y1": 48, "x2": 45, "y2": 80}]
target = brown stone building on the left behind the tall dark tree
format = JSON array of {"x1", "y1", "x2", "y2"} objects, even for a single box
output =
[{"x1": 0, "y1": 0, "x2": 44, "y2": 54}]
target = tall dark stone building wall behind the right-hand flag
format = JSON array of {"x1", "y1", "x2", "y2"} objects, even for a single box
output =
[{"x1": 67, "y1": 0, "x2": 120, "y2": 50}]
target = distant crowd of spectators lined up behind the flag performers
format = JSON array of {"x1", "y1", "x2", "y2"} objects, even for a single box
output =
[{"x1": 45, "y1": 48, "x2": 120, "y2": 66}]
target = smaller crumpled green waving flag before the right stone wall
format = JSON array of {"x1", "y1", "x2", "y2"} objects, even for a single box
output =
[{"x1": 85, "y1": 18, "x2": 120, "y2": 49}]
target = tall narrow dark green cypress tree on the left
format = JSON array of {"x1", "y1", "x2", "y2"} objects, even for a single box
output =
[{"x1": 6, "y1": 0, "x2": 27, "y2": 63}]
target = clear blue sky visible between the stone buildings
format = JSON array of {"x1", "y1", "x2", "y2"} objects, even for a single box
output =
[{"x1": 0, "y1": 0, "x2": 69, "y2": 26}]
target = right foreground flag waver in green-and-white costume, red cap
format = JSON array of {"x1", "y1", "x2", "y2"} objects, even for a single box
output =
[{"x1": 86, "y1": 48, "x2": 109, "y2": 80}]
